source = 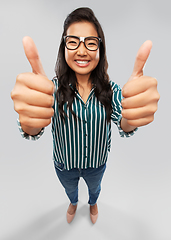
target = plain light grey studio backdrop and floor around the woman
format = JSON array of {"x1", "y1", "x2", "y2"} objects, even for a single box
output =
[{"x1": 0, "y1": 0, "x2": 171, "y2": 240}]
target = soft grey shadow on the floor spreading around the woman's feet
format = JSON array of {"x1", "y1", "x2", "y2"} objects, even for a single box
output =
[{"x1": 3, "y1": 202, "x2": 154, "y2": 240}]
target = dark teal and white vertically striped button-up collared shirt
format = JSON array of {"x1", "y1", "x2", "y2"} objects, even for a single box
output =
[{"x1": 18, "y1": 78, "x2": 137, "y2": 170}]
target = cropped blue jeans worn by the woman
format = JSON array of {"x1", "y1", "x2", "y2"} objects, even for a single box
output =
[{"x1": 55, "y1": 163, "x2": 106, "y2": 206}]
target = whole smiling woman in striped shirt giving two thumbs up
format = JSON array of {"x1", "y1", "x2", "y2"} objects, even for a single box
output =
[{"x1": 11, "y1": 8, "x2": 159, "y2": 223}]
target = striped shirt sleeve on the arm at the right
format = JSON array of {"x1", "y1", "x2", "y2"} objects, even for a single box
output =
[{"x1": 111, "y1": 82, "x2": 138, "y2": 137}]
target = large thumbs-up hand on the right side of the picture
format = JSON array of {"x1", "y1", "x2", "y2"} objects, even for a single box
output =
[{"x1": 122, "y1": 40, "x2": 160, "y2": 127}]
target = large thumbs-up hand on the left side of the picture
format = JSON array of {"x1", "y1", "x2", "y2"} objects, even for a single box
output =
[{"x1": 11, "y1": 37, "x2": 54, "y2": 135}]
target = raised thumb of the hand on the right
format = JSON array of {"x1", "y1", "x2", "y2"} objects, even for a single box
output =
[{"x1": 132, "y1": 40, "x2": 152, "y2": 76}]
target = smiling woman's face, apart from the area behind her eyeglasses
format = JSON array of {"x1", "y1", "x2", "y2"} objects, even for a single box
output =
[{"x1": 65, "y1": 22, "x2": 99, "y2": 81}]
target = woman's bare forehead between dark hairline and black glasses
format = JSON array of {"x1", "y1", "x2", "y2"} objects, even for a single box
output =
[{"x1": 67, "y1": 22, "x2": 98, "y2": 37}]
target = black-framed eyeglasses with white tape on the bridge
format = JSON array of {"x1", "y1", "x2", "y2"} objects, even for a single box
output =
[{"x1": 64, "y1": 35, "x2": 102, "y2": 51}]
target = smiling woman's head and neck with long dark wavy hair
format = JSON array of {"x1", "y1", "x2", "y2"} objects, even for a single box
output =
[{"x1": 55, "y1": 8, "x2": 112, "y2": 121}]
